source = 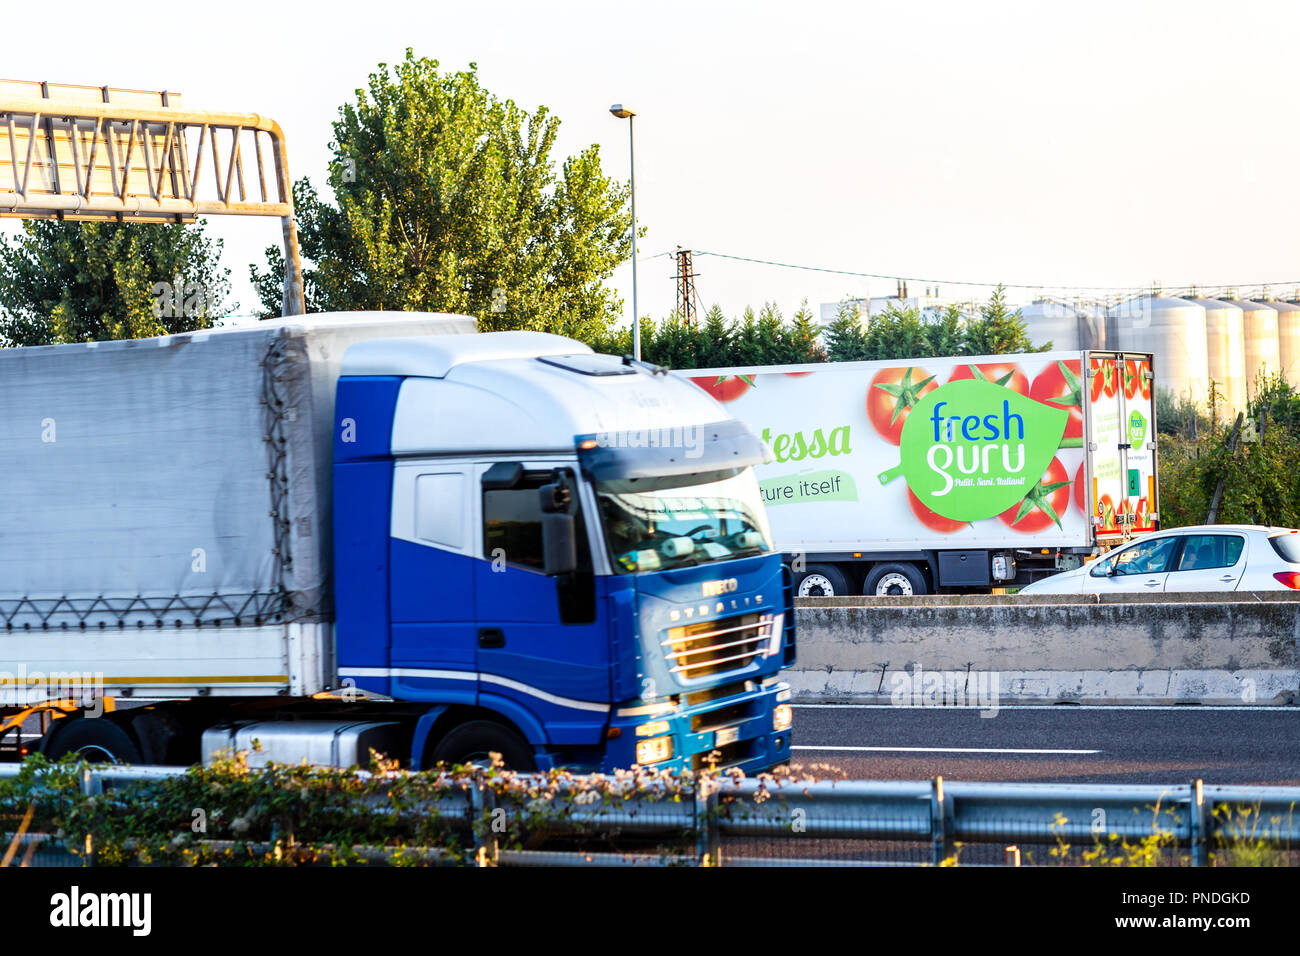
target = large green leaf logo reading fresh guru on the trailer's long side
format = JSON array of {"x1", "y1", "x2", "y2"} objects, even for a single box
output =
[{"x1": 900, "y1": 378, "x2": 1070, "y2": 522}]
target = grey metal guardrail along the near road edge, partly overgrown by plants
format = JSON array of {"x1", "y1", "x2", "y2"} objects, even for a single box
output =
[{"x1": 0, "y1": 765, "x2": 1300, "y2": 866}]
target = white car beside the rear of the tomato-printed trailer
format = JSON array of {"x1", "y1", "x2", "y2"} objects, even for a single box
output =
[{"x1": 1019, "y1": 524, "x2": 1300, "y2": 594}]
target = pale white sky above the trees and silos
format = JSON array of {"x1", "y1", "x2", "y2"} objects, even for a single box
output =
[{"x1": 0, "y1": 0, "x2": 1300, "y2": 317}]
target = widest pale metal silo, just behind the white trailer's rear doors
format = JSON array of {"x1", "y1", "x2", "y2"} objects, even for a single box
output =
[{"x1": 1106, "y1": 295, "x2": 1209, "y2": 406}]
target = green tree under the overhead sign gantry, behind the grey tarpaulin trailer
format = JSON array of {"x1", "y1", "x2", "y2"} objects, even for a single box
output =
[{"x1": 0, "y1": 220, "x2": 230, "y2": 346}]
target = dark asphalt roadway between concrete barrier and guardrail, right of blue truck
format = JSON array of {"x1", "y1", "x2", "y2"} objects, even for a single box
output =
[{"x1": 792, "y1": 704, "x2": 1300, "y2": 786}]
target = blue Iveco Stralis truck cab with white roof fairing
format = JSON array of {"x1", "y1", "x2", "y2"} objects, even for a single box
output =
[{"x1": 333, "y1": 332, "x2": 794, "y2": 773}]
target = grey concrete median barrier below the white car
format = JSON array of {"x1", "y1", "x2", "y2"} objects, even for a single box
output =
[{"x1": 785, "y1": 592, "x2": 1300, "y2": 706}]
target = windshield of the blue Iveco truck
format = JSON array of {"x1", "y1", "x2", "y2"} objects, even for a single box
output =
[{"x1": 595, "y1": 468, "x2": 772, "y2": 574}]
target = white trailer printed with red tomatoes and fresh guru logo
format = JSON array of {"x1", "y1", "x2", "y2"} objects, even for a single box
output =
[{"x1": 677, "y1": 351, "x2": 1160, "y2": 597}]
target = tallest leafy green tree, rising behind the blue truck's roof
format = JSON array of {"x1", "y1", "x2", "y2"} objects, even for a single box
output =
[{"x1": 252, "y1": 49, "x2": 632, "y2": 338}]
